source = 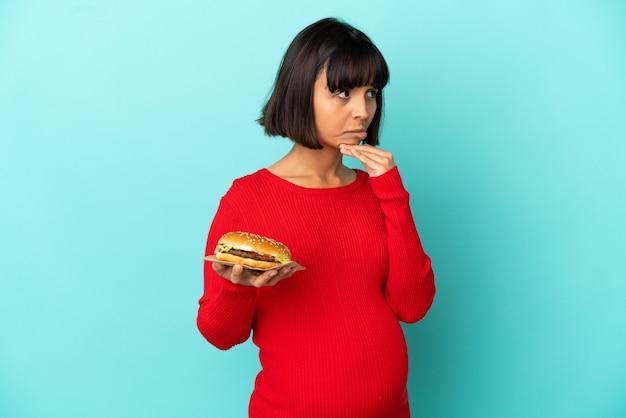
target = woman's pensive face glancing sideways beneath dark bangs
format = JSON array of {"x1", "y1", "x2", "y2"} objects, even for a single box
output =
[{"x1": 313, "y1": 71, "x2": 378, "y2": 148}]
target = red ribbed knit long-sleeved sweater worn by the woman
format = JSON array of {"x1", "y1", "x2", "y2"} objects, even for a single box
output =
[{"x1": 198, "y1": 168, "x2": 435, "y2": 418}]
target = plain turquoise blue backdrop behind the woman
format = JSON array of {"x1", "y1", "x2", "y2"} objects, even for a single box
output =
[{"x1": 0, "y1": 0, "x2": 626, "y2": 418}]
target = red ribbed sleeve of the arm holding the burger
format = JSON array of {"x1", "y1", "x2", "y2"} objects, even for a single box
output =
[{"x1": 197, "y1": 198, "x2": 256, "y2": 350}]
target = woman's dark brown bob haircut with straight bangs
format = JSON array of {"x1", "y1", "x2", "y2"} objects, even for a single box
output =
[{"x1": 257, "y1": 18, "x2": 389, "y2": 149}]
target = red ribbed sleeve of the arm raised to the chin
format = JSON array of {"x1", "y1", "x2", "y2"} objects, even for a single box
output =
[{"x1": 370, "y1": 167, "x2": 435, "y2": 323}]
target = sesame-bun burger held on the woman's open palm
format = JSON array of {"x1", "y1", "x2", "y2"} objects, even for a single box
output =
[{"x1": 215, "y1": 231, "x2": 291, "y2": 269}]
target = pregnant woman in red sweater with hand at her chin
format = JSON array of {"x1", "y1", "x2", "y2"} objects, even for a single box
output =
[{"x1": 198, "y1": 19, "x2": 435, "y2": 418}]
